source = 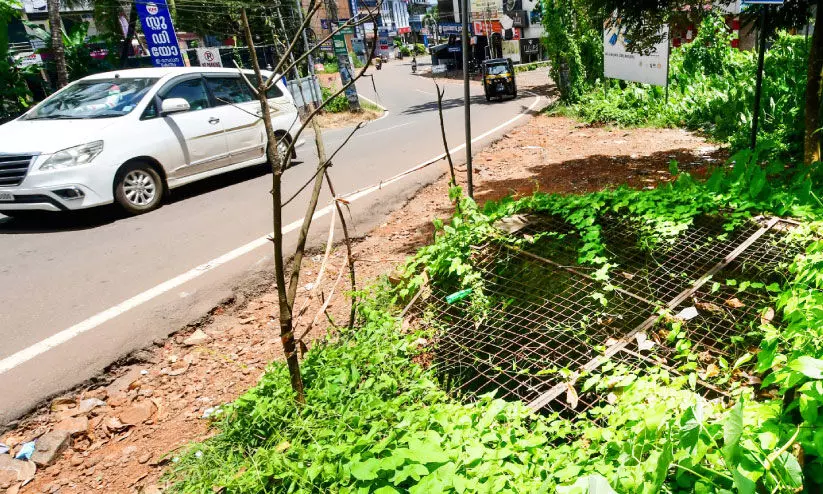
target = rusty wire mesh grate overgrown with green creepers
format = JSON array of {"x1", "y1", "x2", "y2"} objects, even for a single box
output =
[{"x1": 412, "y1": 216, "x2": 800, "y2": 415}]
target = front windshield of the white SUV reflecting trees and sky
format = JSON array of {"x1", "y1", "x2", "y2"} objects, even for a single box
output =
[{"x1": 26, "y1": 77, "x2": 157, "y2": 120}]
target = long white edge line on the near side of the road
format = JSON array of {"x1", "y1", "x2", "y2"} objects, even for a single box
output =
[{"x1": 0, "y1": 91, "x2": 540, "y2": 374}]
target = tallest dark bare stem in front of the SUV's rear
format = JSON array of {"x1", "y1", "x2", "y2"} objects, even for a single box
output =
[{"x1": 240, "y1": 8, "x2": 306, "y2": 404}]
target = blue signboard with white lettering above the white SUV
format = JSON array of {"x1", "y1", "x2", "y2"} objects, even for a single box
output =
[{"x1": 135, "y1": 0, "x2": 186, "y2": 67}]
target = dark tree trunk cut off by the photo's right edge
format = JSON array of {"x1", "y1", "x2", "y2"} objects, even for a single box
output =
[{"x1": 803, "y1": 4, "x2": 823, "y2": 165}]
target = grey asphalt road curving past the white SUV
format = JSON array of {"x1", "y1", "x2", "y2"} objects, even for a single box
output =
[{"x1": 0, "y1": 61, "x2": 537, "y2": 425}]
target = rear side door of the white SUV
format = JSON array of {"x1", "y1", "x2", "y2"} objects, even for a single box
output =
[{"x1": 205, "y1": 74, "x2": 266, "y2": 164}]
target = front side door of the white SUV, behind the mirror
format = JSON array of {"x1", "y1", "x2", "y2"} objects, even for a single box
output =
[{"x1": 158, "y1": 74, "x2": 229, "y2": 178}]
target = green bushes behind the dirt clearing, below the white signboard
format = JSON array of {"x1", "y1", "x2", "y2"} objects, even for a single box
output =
[{"x1": 556, "y1": 15, "x2": 808, "y2": 158}]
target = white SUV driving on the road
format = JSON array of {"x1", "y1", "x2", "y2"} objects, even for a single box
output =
[{"x1": 0, "y1": 67, "x2": 300, "y2": 216}]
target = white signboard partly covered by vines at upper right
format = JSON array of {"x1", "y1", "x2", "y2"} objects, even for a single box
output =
[{"x1": 603, "y1": 16, "x2": 669, "y2": 86}]
